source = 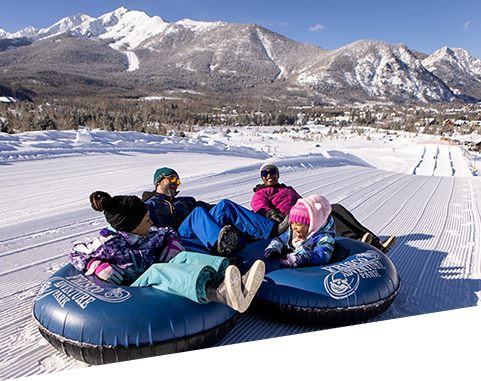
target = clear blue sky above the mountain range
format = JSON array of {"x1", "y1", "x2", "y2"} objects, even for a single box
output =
[{"x1": 0, "y1": 0, "x2": 481, "y2": 59}]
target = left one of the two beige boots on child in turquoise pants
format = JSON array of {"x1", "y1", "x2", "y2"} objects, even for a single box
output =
[{"x1": 205, "y1": 265, "x2": 244, "y2": 313}]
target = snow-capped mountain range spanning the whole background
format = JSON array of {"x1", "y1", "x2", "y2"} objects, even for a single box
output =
[{"x1": 0, "y1": 7, "x2": 481, "y2": 105}]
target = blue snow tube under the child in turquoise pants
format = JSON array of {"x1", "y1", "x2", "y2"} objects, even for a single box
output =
[{"x1": 33, "y1": 264, "x2": 238, "y2": 368}]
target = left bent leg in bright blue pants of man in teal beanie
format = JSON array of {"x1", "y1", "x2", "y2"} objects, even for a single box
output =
[{"x1": 178, "y1": 207, "x2": 222, "y2": 251}]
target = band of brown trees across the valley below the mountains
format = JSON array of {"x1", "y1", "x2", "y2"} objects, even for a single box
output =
[{"x1": 0, "y1": 97, "x2": 481, "y2": 135}]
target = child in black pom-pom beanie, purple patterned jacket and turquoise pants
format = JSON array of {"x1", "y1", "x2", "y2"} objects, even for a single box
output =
[{"x1": 69, "y1": 191, "x2": 265, "y2": 312}]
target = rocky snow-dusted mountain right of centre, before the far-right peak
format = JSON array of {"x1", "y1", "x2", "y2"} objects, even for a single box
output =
[{"x1": 297, "y1": 40, "x2": 455, "y2": 102}]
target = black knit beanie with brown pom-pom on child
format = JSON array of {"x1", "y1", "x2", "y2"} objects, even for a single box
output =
[{"x1": 90, "y1": 191, "x2": 148, "y2": 233}]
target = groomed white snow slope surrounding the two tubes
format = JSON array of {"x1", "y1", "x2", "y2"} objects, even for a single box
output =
[{"x1": 0, "y1": 128, "x2": 481, "y2": 381}]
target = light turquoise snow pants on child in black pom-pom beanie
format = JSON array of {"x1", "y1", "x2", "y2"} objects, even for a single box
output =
[{"x1": 131, "y1": 251, "x2": 230, "y2": 304}]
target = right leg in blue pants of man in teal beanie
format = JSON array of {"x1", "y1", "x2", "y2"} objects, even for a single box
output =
[{"x1": 210, "y1": 199, "x2": 274, "y2": 239}]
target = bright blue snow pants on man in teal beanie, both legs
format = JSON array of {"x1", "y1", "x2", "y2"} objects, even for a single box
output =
[{"x1": 178, "y1": 199, "x2": 274, "y2": 250}]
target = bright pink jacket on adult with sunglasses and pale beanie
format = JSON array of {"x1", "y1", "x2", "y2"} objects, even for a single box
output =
[{"x1": 251, "y1": 184, "x2": 301, "y2": 217}]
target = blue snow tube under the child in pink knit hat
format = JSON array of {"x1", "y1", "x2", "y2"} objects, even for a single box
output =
[{"x1": 237, "y1": 237, "x2": 401, "y2": 326}]
